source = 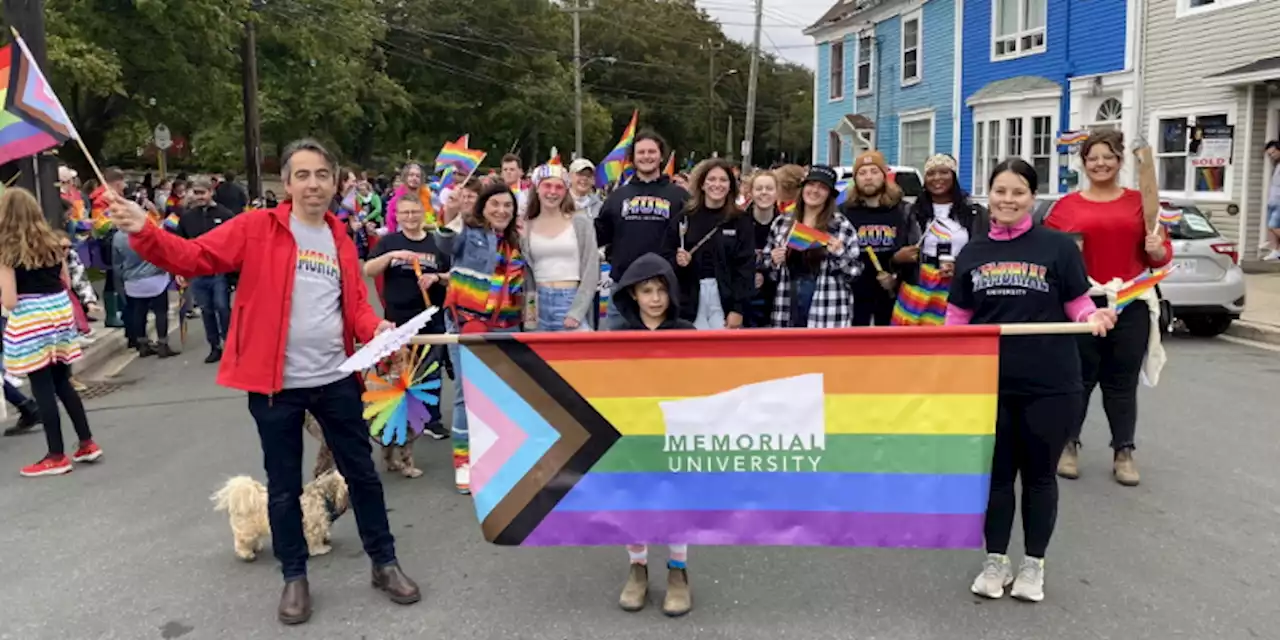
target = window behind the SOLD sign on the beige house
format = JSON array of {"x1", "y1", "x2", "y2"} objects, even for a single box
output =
[{"x1": 1156, "y1": 113, "x2": 1229, "y2": 196}]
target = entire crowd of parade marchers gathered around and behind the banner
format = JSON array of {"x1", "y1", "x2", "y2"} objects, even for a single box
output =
[{"x1": 0, "y1": 131, "x2": 1172, "y2": 623}]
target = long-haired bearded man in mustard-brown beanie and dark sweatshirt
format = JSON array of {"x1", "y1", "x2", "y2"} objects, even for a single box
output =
[{"x1": 841, "y1": 151, "x2": 906, "y2": 326}]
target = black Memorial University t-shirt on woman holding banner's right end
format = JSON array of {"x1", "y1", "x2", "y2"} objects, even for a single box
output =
[{"x1": 947, "y1": 227, "x2": 1089, "y2": 396}]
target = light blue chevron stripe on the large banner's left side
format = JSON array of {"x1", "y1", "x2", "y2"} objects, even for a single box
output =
[{"x1": 454, "y1": 347, "x2": 559, "y2": 522}]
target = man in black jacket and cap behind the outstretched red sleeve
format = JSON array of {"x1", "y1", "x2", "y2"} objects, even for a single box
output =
[{"x1": 175, "y1": 178, "x2": 236, "y2": 365}]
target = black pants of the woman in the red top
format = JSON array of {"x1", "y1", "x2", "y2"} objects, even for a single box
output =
[{"x1": 1069, "y1": 298, "x2": 1151, "y2": 451}]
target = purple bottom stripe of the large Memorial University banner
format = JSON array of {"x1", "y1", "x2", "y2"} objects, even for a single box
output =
[{"x1": 521, "y1": 511, "x2": 984, "y2": 549}]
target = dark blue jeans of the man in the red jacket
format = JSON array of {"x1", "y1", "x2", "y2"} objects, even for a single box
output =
[{"x1": 248, "y1": 376, "x2": 396, "y2": 581}]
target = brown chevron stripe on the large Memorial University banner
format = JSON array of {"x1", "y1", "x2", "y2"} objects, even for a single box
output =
[{"x1": 462, "y1": 338, "x2": 589, "y2": 541}]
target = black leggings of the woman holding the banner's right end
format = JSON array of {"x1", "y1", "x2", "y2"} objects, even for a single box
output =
[{"x1": 984, "y1": 393, "x2": 1080, "y2": 558}]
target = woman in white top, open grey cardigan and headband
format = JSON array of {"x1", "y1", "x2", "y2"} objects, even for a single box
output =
[{"x1": 520, "y1": 160, "x2": 600, "y2": 332}]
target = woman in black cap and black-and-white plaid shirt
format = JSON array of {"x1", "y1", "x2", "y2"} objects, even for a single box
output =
[{"x1": 764, "y1": 165, "x2": 863, "y2": 328}]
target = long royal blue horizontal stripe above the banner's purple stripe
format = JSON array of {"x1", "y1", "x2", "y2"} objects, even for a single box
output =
[{"x1": 552, "y1": 471, "x2": 991, "y2": 513}]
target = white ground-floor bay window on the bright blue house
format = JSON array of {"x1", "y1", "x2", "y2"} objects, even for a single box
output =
[{"x1": 972, "y1": 96, "x2": 1062, "y2": 197}]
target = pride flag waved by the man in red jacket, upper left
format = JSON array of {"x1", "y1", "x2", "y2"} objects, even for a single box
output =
[{"x1": 0, "y1": 31, "x2": 79, "y2": 164}]
